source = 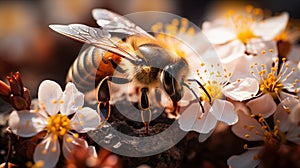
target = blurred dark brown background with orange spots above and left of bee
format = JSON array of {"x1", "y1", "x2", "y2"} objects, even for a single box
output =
[{"x1": 0, "y1": 0, "x2": 300, "y2": 97}]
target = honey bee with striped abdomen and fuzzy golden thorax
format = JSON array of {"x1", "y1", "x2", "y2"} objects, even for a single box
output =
[{"x1": 49, "y1": 9, "x2": 209, "y2": 131}]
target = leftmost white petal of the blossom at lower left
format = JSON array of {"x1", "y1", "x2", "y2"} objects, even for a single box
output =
[{"x1": 8, "y1": 110, "x2": 47, "y2": 137}]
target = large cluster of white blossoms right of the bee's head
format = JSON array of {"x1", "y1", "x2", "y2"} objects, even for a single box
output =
[{"x1": 169, "y1": 6, "x2": 300, "y2": 168}]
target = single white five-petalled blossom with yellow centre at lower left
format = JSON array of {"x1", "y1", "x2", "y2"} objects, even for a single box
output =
[{"x1": 9, "y1": 80, "x2": 100, "y2": 167}]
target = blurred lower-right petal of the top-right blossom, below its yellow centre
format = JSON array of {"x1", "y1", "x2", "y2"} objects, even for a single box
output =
[{"x1": 246, "y1": 38, "x2": 278, "y2": 58}]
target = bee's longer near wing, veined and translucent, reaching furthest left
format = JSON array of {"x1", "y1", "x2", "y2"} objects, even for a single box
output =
[{"x1": 49, "y1": 24, "x2": 137, "y2": 61}]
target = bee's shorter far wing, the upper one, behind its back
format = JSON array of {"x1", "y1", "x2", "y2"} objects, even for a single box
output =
[{"x1": 92, "y1": 9, "x2": 154, "y2": 38}]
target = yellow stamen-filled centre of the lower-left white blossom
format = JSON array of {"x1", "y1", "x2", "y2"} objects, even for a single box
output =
[{"x1": 46, "y1": 114, "x2": 71, "y2": 136}]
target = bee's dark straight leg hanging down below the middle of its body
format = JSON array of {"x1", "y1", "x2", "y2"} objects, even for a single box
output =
[{"x1": 139, "y1": 88, "x2": 152, "y2": 134}]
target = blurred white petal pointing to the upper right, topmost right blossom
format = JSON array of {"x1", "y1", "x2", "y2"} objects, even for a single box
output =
[{"x1": 253, "y1": 12, "x2": 289, "y2": 40}]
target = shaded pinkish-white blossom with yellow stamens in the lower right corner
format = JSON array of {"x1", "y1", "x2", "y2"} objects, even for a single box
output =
[{"x1": 227, "y1": 95, "x2": 300, "y2": 168}]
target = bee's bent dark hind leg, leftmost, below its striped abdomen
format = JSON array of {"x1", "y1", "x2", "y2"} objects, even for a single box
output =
[{"x1": 96, "y1": 76, "x2": 129, "y2": 126}]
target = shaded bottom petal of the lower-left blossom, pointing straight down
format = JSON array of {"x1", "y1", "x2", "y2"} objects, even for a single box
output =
[{"x1": 33, "y1": 134, "x2": 60, "y2": 168}]
